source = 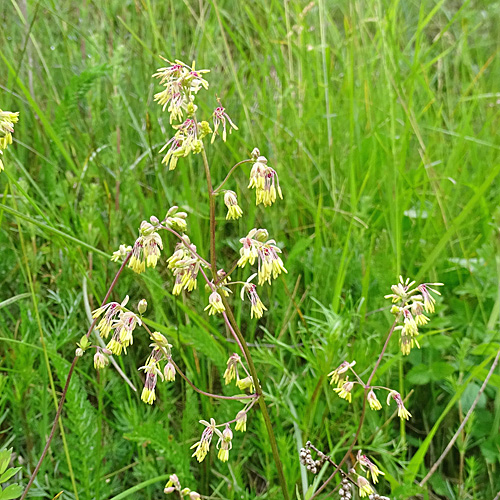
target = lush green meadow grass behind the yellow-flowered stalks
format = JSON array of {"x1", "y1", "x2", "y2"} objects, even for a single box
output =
[{"x1": 0, "y1": 0, "x2": 500, "y2": 500}]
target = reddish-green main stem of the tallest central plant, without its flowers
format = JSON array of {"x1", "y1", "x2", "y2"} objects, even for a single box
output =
[{"x1": 201, "y1": 149, "x2": 290, "y2": 500}]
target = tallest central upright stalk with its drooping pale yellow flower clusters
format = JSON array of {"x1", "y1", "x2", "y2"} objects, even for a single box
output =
[{"x1": 153, "y1": 57, "x2": 289, "y2": 500}]
